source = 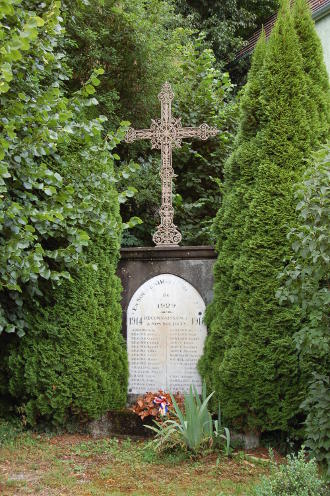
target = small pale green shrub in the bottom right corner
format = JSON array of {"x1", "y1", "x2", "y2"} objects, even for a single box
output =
[{"x1": 253, "y1": 449, "x2": 328, "y2": 496}]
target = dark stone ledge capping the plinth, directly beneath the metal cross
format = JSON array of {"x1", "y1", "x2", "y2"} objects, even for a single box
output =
[{"x1": 120, "y1": 246, "x2": 217, "y2": 261}]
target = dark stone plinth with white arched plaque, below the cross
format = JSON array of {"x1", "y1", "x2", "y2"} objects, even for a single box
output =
[{"x1": 118, "y1": 246, "x2": 216, "y2": 401}]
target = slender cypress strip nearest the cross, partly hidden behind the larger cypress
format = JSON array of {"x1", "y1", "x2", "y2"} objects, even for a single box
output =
[{"x1": 199, "y1": 32, "x2": 266, "y2": 396}]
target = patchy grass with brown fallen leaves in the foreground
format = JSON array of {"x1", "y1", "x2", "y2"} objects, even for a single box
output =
[{"x1": 0, "y1": 426, "x2": 268, "y2": 496}]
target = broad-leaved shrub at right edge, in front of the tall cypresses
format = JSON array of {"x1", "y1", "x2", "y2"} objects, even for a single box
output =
[{"x1": 277, "y1": 143, "x2": 330, "y2": 360}]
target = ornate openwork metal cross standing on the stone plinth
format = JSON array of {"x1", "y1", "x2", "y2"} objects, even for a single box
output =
[{"x1": 126, "y1": 82, "x2": 219, "y2": 247}]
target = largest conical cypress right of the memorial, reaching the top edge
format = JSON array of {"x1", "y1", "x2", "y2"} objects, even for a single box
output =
[{"x1": 201, "y1": 1, "x2": 328, "y2": 432}]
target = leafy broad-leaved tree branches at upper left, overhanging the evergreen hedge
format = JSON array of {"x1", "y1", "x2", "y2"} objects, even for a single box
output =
[{"x1": 0, "y1": 0, "x2": 123, "y2": 336}]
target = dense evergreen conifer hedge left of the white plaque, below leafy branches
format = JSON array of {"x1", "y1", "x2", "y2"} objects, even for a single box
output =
[{"x1": 8, "y1": 144, "x2": 128, "y2": 425}]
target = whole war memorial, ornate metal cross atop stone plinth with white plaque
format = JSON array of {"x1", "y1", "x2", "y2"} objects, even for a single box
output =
[{"x1": 118, "y1": 83, "x2": 218, "y2": 399}]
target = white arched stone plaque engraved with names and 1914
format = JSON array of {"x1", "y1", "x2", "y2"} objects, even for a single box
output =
[{"x1": 127, "y1": 274, "x2": 206, "y2": 394}]
